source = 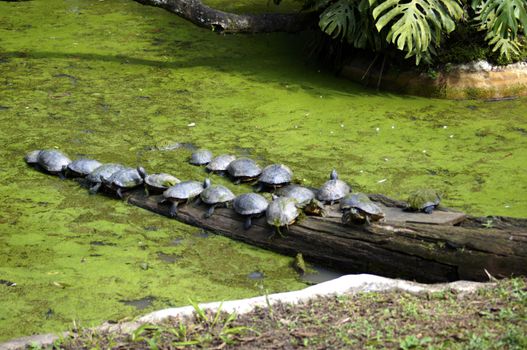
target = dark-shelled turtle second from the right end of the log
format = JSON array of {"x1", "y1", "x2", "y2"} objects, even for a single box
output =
[{"x1": 340, "y1": 192, "x2": 384, "y2": 225}]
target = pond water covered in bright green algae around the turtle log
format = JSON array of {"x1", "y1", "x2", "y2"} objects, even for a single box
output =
[{"x1": 0, "y1": 0, "x2": 527, "y2": 340}]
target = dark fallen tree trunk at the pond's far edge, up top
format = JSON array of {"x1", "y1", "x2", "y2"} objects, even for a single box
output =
[{"x1": 134, "y1": 0, "x2": 315, "y2": 33}]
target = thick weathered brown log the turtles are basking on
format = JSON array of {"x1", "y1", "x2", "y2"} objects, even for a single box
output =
[{"x1": 127, "y1": 190, "x2": 527, "y2": 282}]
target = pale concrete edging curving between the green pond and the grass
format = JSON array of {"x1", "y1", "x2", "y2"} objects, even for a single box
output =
[{"x1": 0, "y1": 274, "x2": 494, "y2": 350}]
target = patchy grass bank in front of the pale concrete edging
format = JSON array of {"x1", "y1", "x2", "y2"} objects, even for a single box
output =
[{"x1": 29, "y1": 278, "x2": 527, "y2": 350}]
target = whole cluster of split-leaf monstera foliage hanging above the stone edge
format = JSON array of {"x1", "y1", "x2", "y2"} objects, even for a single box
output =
[{"x1": 288, "y1": 0, "x2": 527, "y2": 65}]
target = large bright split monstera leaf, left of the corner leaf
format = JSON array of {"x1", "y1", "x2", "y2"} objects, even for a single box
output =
[{"x1": 369, "y1": 0, "x2": 463, "y2": 64}]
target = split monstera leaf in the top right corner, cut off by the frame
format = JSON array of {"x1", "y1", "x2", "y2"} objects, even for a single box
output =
[{"x1": 472, "y1": 0, "x2": 527, "y2": 59}]
